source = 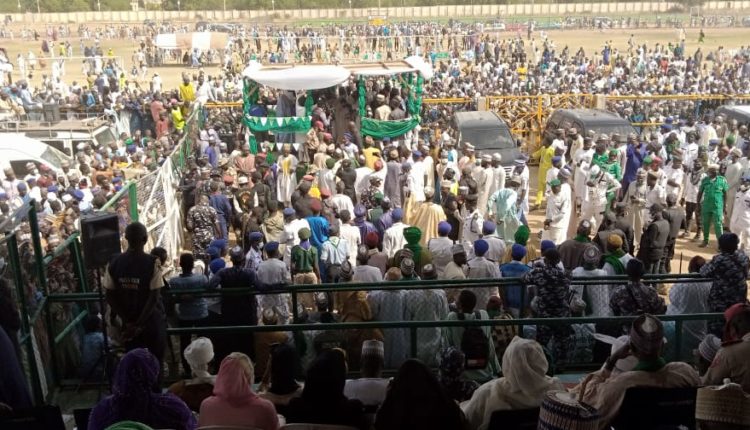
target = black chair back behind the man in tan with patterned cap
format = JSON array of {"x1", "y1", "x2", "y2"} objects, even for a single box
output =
[{"x1": 612, "y1": 387, "x2": 698, "y2": 430}]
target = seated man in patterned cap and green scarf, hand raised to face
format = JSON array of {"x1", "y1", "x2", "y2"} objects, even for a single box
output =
[{"x1": 574, "y1": 314, "x2": 701, "y2": 428}]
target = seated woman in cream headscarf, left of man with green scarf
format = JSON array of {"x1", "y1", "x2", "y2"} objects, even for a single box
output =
[{"x1": 461, "y1": 336, "x2": 565, "y2": 430}]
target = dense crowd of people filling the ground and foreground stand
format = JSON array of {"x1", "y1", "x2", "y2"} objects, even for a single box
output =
[{"x1": 0, "y1": 18, "x2": 750, "y2": 430}]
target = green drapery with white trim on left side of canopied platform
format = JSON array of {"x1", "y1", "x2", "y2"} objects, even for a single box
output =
[{"x1": 242, "y1": 79, "x2": 314, "y2": 154}]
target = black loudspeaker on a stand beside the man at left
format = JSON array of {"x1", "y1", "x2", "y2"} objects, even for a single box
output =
[{"x1": 81, "y1": 213, "x2": 122, "y2": 269}]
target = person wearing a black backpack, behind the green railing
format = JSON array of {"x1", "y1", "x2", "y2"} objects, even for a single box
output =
[{"x1": 443, "y1": 290, "x2": 500, "y2": 383}]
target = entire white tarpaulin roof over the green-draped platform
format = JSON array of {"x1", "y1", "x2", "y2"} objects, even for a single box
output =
[{"x1": 242, "y1": 57, "x2": 432, "y2": 90}]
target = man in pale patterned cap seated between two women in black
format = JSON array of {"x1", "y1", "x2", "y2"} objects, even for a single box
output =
[{"x1": 344, "y1": 340, "x2": 388, "y2": 406}]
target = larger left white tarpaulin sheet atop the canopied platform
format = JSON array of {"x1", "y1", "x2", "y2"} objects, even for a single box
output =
[{"x1": 242, "y1": 61, "x2": 351, "y2": 91}]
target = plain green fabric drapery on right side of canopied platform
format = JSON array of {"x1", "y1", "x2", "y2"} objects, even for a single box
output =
[{"x1": 357, "y1": 73, "x2": 424, "y2": 139}]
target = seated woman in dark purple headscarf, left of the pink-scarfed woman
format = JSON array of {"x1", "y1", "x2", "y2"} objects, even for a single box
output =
[{"x1": 89, "y1": 348, "x2": 197, "y2": 430}]
